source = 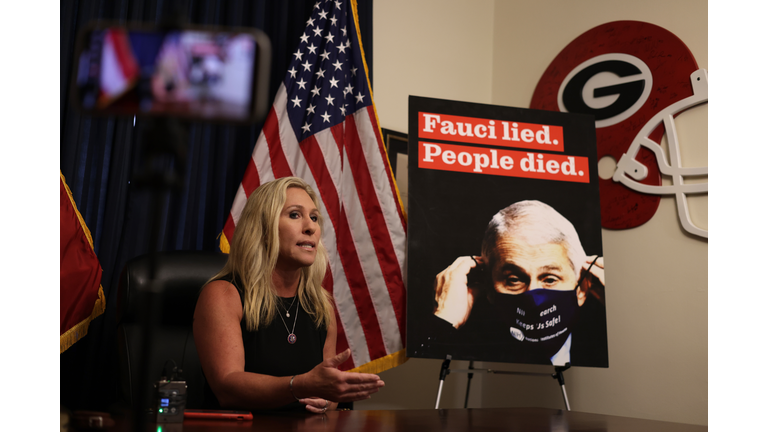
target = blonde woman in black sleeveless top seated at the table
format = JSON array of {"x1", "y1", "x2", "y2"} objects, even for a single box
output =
[{"x1": 193, "y1": 177, "x2": 384, "y2": 413}]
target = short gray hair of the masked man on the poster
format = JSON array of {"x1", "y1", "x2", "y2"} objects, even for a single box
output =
[{"x1": 482, "y1": 201, "x2": 587, "y2": 276}]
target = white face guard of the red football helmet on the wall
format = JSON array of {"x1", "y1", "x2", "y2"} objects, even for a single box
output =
[{"x1": 613, "y1": 69, "x2": 709, "y2": 238}]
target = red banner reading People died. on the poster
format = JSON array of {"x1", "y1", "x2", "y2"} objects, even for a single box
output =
[{"x1": 419, "y1": 141, "x2": 589, "y2": 183}]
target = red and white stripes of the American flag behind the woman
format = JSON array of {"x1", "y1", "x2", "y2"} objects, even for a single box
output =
[{"x1": 222, "y1": 85, "x2": 406, "y2": 369}]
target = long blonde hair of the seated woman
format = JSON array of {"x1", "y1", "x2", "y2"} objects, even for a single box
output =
[{"x1": 211, "y1": 177, "x2": 333, "y2": 331}]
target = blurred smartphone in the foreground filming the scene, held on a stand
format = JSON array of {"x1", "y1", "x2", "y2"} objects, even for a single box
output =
[{"x1": 72, "y1": 22, "x2": 271, "y2": 123}]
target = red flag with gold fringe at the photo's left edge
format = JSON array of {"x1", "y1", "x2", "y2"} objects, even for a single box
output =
[{"x1": 59, "y1": 172, "x2": 106, "y2": 353}]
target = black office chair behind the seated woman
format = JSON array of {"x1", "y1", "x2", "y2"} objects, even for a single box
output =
[{"x1": 117, "y1": 251, "x2": 227, "y2": 408}]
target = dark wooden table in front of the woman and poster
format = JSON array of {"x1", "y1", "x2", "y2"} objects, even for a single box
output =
[{"x1": 152, "y1": 408, "x2": 707, "y2": 432}]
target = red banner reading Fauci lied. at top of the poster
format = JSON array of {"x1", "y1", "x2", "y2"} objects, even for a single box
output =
[{"x1": 419, "y1": 112, "x2": 565, "y2": 152}]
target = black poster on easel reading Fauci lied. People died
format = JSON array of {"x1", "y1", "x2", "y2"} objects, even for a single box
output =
[{"x1": 406, "y1": 96, "x2": 608, "y2": 367}]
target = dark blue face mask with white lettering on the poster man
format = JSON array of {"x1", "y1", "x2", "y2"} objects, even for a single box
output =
[{"x1": 489, "y1": 289, "x2": 579, "y2": 363}]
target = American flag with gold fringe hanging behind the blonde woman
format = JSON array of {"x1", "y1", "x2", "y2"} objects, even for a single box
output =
[{"x1": 221, "y1": 0, "x2": 406, "y2": 373}]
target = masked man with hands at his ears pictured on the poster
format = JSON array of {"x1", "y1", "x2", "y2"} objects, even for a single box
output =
[{"x1": 434, "y1": 201, "x2": 607, "y2": 366}]
